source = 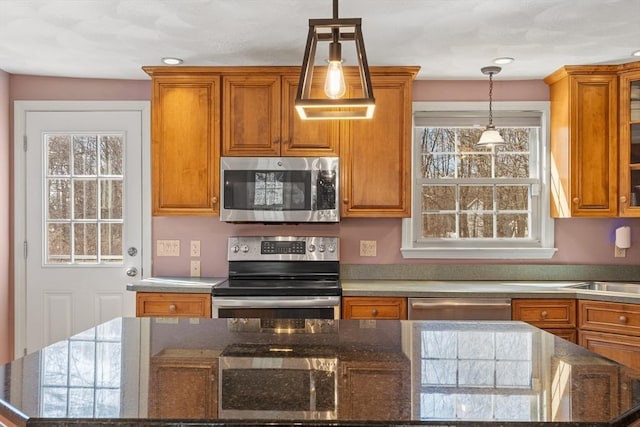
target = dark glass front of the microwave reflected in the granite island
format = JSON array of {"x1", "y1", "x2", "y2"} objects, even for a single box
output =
[{"x1": 221, "y1": 369, "x2": 336, "y2": 412}]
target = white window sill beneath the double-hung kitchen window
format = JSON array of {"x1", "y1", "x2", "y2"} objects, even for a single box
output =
[{"x1": 400, "y1": 248, "x2": 557, "y2": 259}]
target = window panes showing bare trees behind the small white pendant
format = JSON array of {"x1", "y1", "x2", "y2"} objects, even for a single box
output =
[{"x1": 417, "y1": 127, "x2": 538, "y2": 240}]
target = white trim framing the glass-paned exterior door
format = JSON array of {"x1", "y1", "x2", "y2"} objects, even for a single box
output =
[{"x1": 13, "y1": 101, "x2": 152, "y2": 358}]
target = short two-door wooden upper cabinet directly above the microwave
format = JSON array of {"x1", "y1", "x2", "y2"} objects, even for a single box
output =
[{"x1": 222, "y1": 73, "x2": 339, "y2": 157}]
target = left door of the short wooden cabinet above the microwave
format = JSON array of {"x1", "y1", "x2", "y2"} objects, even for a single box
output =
[{"x1": 222, "y1": 74, "x2": 281, "y2": 156}]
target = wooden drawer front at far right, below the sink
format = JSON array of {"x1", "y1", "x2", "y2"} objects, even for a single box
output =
[{"x1": 579, "y1": 300, "x2": 640, "y2": 336}]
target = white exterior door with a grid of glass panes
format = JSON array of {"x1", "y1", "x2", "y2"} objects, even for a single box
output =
[{"x1": 16, "y1": 103, "x2": 148, "y2": 355}]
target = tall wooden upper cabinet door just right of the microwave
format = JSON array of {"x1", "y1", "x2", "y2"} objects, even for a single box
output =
[{"x1": 340, "y1": 75, "x2": 412, "y2": 218}]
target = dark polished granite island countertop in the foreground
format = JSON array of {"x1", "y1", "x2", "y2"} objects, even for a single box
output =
[{"x1": 0, "y1": 318, "x2": 640, "y2": 427}]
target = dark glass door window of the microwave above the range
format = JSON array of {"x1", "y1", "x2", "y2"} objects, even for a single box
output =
[{"x1": 224, "y1": 170, "x2": 311, "y2": 211}]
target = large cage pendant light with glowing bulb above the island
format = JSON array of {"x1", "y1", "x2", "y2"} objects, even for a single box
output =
[{"x1": 295, "y1": 0, "x2": 375, "y2": 120}]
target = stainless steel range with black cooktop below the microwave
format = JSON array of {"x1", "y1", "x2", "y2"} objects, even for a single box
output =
[{"x1": 212, "y1": 236, "x2": 342, "y2": 319}]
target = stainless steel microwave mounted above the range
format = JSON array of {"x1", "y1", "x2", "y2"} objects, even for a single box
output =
[{"x1": 220, "y1": 157, "x2": 340, "y2": 223}]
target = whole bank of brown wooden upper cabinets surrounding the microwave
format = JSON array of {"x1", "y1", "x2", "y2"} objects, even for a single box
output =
[{"x1": 143, "y1": 67, "x2": 419, "y2": 217}]
